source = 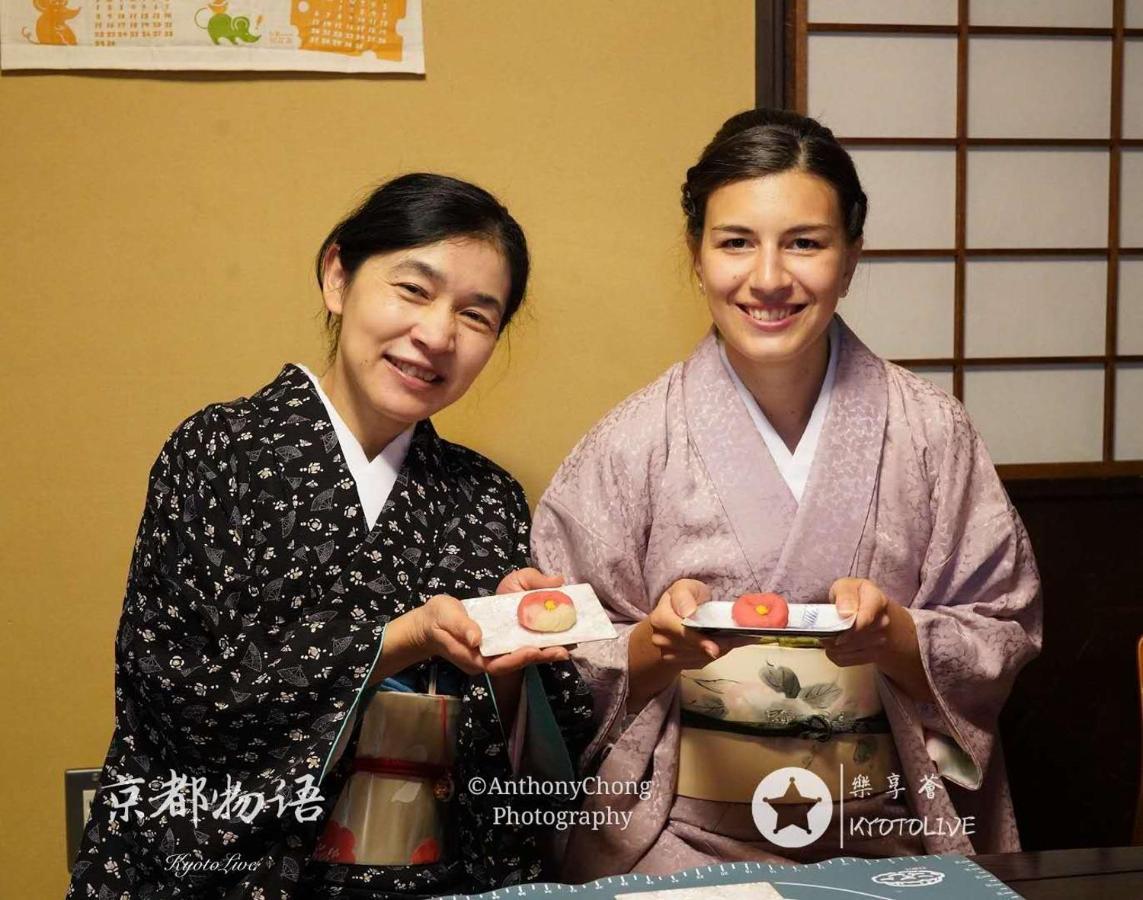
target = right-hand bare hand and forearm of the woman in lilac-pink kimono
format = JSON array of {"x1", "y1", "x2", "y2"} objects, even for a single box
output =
[{"x1": 824, "y1": 578, "x2": 933, "y2": 702}]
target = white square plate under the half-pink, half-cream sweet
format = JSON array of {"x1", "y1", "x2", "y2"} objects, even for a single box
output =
[{"x1": 461, "y1": 584, "x2": 618, "y2": 656}]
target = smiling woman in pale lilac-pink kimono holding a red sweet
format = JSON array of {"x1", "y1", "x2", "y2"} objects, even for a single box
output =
[{"x1": 533, "y1": 110, "x2": 1040, "y2": 879}]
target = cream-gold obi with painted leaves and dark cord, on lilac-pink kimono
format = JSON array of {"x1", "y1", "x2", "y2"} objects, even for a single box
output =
[{"x1": 677, "y1": 638, "x2": 902, "y2": 803}]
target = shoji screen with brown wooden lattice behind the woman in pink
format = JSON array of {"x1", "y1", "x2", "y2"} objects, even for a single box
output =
[{"x1": 794, "y1": 0, "x2": 1143, "y2": 477}]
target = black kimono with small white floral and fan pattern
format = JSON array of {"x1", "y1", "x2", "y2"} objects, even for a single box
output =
[{"x1": 67, "y1": 366, "x2": 591, "y2": 900}]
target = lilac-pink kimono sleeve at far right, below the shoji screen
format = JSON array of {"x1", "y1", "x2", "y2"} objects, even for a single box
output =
[{"x1": 909, "y1": 405, "x2": 1041, "y2": 789}]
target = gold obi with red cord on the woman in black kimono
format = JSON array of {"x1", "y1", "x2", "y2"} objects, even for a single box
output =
[{"x1": 314, "y1": 691, "x2": 461, "y2": 866}]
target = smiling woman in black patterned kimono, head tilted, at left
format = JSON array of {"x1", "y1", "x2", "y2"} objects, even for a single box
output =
[{"x1": 69, "y1": 175, "x2": 591, "y2": 900}]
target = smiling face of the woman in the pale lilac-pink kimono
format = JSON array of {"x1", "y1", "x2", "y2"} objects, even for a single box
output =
[{"x1": 695, "y1": 169, "x2": 861, "y2": 371}]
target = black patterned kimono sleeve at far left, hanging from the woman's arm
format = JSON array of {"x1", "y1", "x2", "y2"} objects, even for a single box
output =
[{"x1": 117, "y1": 414, "x2": 383, "y2": 776}]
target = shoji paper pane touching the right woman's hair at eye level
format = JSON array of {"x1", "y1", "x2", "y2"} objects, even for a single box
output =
[{"x1": 850, "y1": 148, "x2": 957, "y2": 249}]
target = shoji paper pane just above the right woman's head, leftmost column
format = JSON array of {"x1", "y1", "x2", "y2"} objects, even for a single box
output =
[{"x1": 806, "y1": 34, "x2": 960, "y2": 137}]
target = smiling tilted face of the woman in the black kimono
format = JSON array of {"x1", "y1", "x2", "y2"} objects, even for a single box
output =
[{"x1": 322, "y1": 238, "x2": 511, "y2": 456}]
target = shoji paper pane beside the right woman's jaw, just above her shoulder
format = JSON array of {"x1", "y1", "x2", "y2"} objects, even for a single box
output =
[{"x1": 838, "y1": 260, "x2": 954, "y2": 359}]
